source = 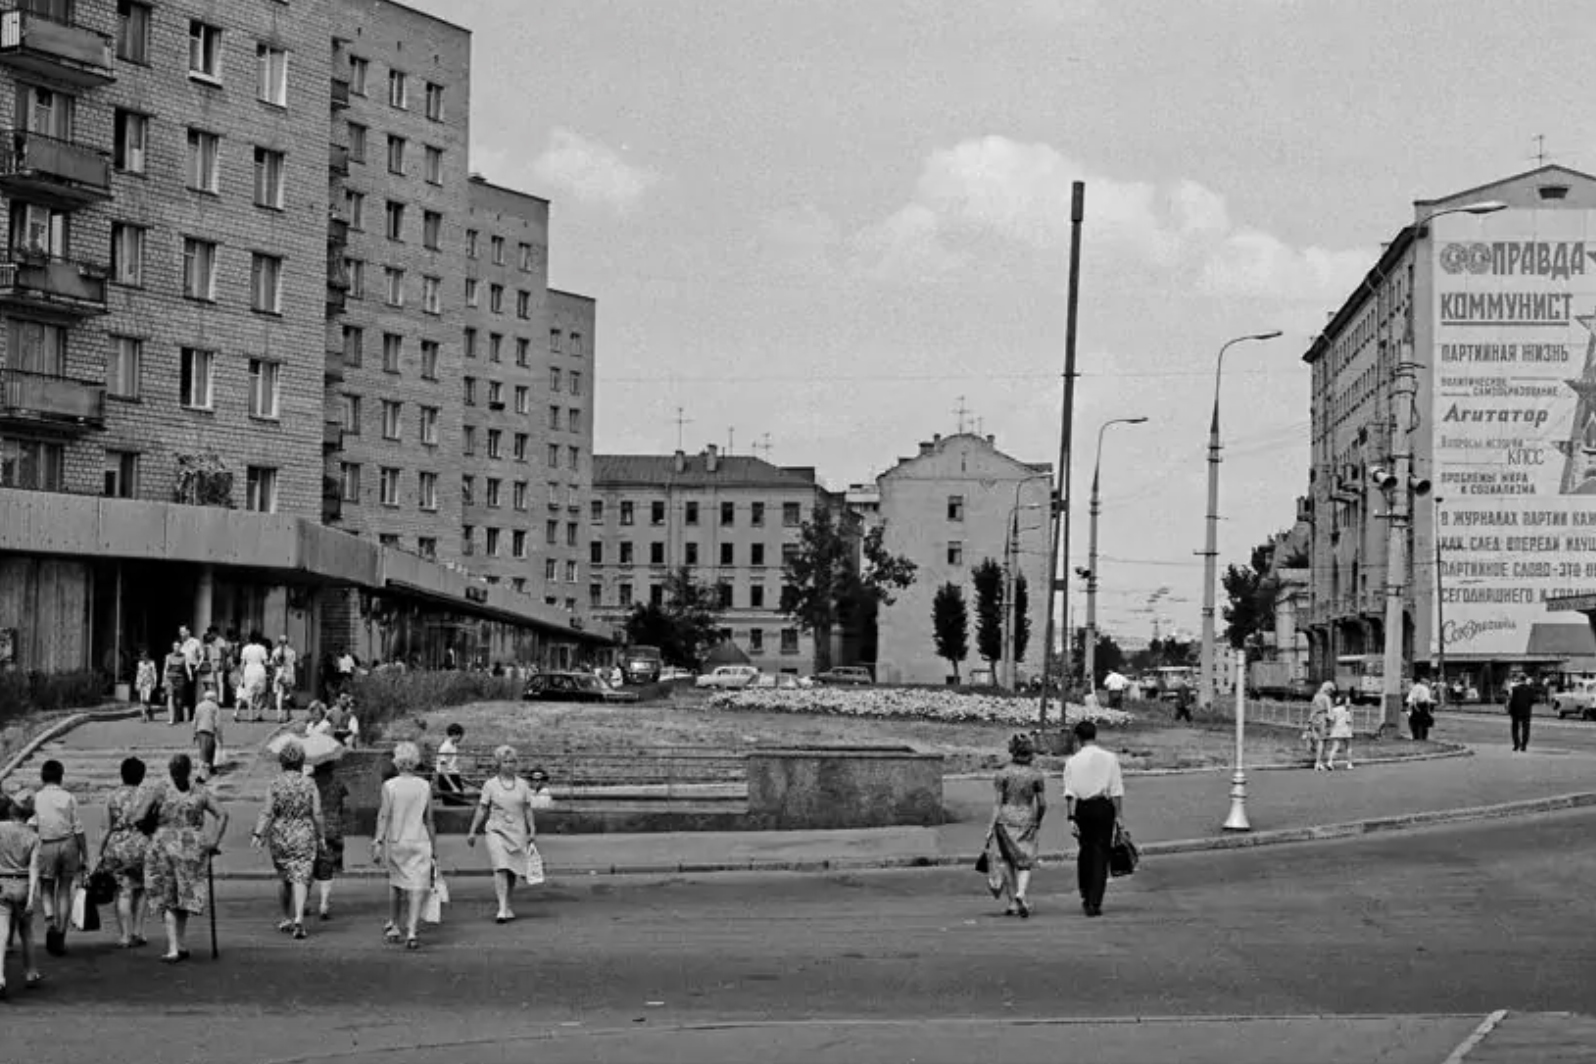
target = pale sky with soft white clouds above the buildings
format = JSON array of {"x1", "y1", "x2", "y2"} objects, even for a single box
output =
[{"x1": 412, "y1": 0, "x2": 1596, "y2": 638}]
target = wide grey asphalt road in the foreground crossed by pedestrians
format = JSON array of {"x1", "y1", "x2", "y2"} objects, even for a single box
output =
[{"x1": 0, "y1": 810, "x2": 1596, "y2": 1064}]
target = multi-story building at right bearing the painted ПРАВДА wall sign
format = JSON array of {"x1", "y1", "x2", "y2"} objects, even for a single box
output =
[{"x1": 1299, "y1": 166, "x2": 1596, "y2": 696}]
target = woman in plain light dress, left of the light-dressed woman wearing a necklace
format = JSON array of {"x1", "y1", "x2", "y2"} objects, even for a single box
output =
[{"x1": 372, "y1": 742, "x2": 436, "y2": 949}]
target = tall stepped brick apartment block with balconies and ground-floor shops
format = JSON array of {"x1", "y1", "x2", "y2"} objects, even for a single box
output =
[{"x1": 0, "y1": 0, "x2": 606, "y2": 692}]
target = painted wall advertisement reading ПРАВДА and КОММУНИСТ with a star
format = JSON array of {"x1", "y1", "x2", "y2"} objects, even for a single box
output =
[{"x1": 1424, "y1": 211, "x2": 1596, "y2": 659}]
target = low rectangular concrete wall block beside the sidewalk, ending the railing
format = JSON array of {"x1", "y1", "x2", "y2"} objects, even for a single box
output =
[{"x1": 749, "y1": 747, "x2": 943, "y2": 831}]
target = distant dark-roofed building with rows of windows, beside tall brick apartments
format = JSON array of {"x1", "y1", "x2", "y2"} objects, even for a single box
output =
[{"x1": 587, "y1": 445, "x2": 851, "y2": 673}]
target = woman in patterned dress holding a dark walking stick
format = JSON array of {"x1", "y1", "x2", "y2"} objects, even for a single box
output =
[{"x1": 132, "y1": 753, "x2": 227, "y2": 964}]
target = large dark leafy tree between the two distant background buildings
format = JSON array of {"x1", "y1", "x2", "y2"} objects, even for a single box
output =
[{"x1": 782, "y1": 504, "x2": 916, "y2": 672}]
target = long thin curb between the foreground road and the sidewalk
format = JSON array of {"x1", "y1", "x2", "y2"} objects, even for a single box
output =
[{"x1": 205, "y1": 791, "x2": 1596, "y2": 882}]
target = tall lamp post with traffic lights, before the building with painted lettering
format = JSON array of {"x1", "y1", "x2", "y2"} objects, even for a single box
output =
[{"x1": 1374, "y1": 199, "x2": 1507, "y2": 731}]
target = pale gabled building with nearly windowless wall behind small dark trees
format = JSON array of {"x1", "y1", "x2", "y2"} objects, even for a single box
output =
[{"x1": 876, "y1": 432, "x2": 1052, "y2": 684}]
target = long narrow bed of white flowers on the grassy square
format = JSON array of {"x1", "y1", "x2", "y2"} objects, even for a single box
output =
[{"x1": 709, "y1": 688, "x2": 1135, "y2": 727}]
